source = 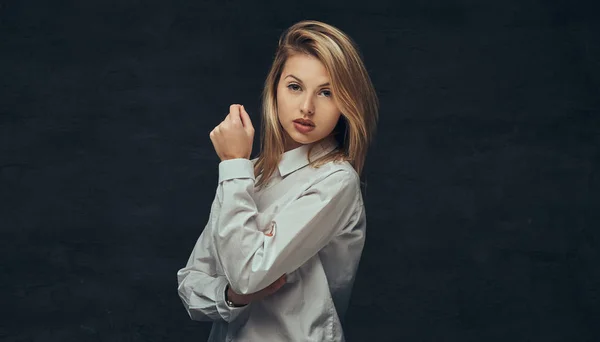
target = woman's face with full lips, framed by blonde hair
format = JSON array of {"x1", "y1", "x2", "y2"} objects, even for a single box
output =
[{"x1": 277, "y1": 54, "x2": 341, "y2": 151}]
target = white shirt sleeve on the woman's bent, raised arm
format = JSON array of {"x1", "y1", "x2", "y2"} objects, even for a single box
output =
[{"x1": 212, "y1": 159, "x2": 360, "y2": 294}]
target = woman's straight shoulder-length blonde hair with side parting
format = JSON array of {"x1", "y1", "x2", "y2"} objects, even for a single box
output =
[{"x1": 254, "y1": 20, "x2": 379, "y2": 187}]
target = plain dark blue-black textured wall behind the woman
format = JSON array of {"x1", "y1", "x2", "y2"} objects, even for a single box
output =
[{"x1": 0, "y1": 0, "x2": 600, "y2": 342}]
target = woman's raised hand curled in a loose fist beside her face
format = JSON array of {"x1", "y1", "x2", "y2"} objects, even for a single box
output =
[{"x1": 210, "y1": 104, "x2": 254, "y2": 161}]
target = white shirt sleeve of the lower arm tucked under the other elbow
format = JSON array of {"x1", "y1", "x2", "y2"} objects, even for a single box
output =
[{"x1": 177, "y1": 199, "x2": 250, "y2": 322}]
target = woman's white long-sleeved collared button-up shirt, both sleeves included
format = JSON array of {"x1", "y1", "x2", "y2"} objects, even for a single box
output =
[{"x1": 177, "y1": 139, "x2": 366, "y2": 342}]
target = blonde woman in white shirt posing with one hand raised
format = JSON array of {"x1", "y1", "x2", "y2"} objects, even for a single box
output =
[{"x1": 177, "y1": 21, "x2": 378, "y2": 342}]
